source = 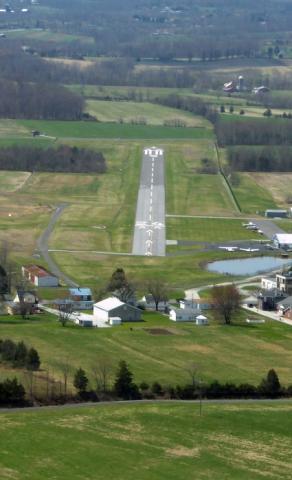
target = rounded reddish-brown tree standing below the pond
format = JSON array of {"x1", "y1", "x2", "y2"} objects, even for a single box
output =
[{"x1": 211, "y1": 285, "x2": 240, "y2": 325}]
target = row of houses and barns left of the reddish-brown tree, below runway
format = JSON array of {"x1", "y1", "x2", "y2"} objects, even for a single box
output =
[{"x1": 3, "y1": 265, "x2": 212, "y2": 327}]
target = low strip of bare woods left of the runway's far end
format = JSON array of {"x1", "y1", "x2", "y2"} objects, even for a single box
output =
[{"x1": 0, "y1": 145, "x2": 106, "y2": 173}]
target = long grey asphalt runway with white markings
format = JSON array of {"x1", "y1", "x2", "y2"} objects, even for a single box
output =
[{"x1": 132, "y1": 147, "x2": 165, "y2": 256}]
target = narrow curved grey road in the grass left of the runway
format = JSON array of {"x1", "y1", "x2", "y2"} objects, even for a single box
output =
[{"x1": 37, "y1": 203, "x2": 78, "y2": 287}]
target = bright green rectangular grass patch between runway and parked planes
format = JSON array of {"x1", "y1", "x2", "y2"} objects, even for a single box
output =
[{"x1": 166, "y1": 217, "x2": 259, "y2": 242}]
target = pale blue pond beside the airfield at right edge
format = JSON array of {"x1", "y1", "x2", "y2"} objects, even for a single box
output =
[{"x1": 207, "y1": 256, "x2": 292, "y2": 275}]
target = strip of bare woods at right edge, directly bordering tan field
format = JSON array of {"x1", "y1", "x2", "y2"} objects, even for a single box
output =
[{"x1": 227, "y1": 146, "x2": 292, "y2": 172}]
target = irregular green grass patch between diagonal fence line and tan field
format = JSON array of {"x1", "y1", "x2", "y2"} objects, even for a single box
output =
[{"x1": 232, "y1": 173, "x2": 277, "y2": 215}]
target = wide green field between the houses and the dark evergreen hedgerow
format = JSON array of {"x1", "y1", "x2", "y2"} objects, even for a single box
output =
[{"x1": 0, "y1": 311, "x2": 292, "y2": 388}]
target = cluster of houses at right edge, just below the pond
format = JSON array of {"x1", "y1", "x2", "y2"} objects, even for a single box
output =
[{"x1": 244, "y1": 269, "x2": 292, "y2": 319}]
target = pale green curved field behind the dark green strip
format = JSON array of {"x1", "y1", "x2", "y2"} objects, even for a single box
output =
[{"x1": 85, "y1": 100, "x2": 211, "y2": 128}]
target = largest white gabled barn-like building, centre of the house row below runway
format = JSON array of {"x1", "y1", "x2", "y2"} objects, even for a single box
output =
[{"x1": 93, "y1": 297, "x2": 142, "y2": 322}]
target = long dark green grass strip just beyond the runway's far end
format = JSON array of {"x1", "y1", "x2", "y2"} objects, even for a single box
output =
[{"x1": 16, "y1": 120, "x2": 213, "y2": 140}]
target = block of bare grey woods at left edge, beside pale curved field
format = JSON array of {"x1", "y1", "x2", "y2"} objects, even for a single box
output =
[{"x1": 0, "y1": 79, "x2": 84, "y2": 120}]
